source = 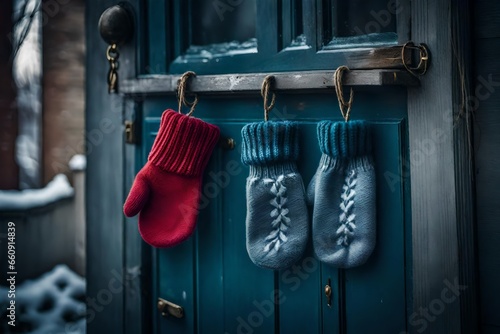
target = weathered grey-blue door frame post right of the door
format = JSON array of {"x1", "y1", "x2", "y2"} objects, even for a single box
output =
[{"x1": 408, "y1": 0, "x2": 478, "y2": 333}]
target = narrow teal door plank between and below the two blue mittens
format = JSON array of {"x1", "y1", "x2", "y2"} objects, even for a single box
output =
[{"x1": 278, "y1": 122, "x2": 332, "y2": 334}]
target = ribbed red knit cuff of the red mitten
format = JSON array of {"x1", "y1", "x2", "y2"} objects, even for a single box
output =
[{"x1": 148, "y1": 109, "x2": 220, "y2": 176}]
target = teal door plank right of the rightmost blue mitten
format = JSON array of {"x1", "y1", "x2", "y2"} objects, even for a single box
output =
[{"x1": 345, "y1": 121, "x2": 406, "y2": 333}]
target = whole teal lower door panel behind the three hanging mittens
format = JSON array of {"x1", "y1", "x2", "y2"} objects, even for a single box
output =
[{"x1": 142, "y1": 89, "x2": 408, "y2": 333}]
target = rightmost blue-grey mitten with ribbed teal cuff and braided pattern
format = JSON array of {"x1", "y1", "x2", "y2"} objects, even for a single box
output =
[{"x1": 308, "y1": 121, "x2": 376, "y2": 268}]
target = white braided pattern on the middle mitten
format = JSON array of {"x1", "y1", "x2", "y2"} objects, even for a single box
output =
[{"x1": 264, "y1": 175, "x2": 290, "y2": 252}]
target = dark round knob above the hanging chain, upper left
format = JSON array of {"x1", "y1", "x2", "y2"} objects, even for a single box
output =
[{"x1": 99, "y1": 5, "x2": 134, "y2": 45}]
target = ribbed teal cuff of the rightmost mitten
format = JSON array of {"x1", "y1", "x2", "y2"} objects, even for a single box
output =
[{"x1": 317, "y1": 121, "x2": 372, "y2": 159}]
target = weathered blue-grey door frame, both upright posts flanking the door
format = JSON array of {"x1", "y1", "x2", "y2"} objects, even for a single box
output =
[{"x1": 86, "y1": 0, "x2": 477, "y2": 333}]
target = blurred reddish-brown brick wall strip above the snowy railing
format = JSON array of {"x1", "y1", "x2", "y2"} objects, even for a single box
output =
[{"x1": 43, "y1": 0, "x2": 85, "y2": 184}]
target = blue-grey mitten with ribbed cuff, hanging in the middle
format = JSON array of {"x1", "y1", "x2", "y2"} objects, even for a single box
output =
[{"x1": 241, "y1": 121, "x2": 309, "y2": 269}]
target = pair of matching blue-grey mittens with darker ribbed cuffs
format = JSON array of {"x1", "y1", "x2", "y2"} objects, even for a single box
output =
[{"x1": 241, "y1": 121, "x2": 376, "y2": 270}]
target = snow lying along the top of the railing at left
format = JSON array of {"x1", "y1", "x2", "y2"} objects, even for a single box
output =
[{"x1": 0, "y1": 174, "x2": 74, "y2": 211}]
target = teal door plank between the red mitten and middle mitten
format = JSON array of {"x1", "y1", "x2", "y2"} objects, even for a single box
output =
[{"x1": 197, "y1": 120, "x2": 274, "y2": 334}]
